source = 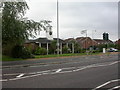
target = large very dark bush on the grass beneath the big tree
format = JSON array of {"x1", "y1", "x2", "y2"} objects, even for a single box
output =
[{"x1": 12, "y1": 45, "x2": 34, "y2": 59}]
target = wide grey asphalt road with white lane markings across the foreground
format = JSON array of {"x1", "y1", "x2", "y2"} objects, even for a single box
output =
[{"x1": 1, "y1": 54, "x2": 120, "y2": 90}]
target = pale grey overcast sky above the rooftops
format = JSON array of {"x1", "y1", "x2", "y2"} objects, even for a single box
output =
[{"x1": 26, "y1": 0, "x2": 118, "y2": 41}]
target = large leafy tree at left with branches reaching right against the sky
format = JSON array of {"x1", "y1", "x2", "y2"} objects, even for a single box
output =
[{"x1": 1, "y1": 1, "x2": 51, "y2": 55}]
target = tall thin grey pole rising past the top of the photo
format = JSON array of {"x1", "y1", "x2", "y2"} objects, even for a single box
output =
[{"x1": 57, "y1": 0, "x2": 59, "y2": 56}]
